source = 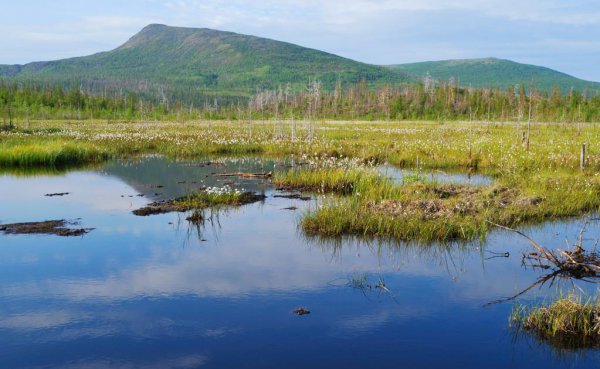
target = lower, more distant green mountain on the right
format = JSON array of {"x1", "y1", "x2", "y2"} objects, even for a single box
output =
[{"x1": 389, "y1": 58, "x2": 600, "y2": 93}]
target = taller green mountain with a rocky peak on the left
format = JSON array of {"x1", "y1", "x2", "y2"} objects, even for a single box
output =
[{"x1": 0, "y1": 24, "x2": 408, "y2": 99}]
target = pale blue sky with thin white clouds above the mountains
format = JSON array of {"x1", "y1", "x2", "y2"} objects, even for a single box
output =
[{"x1": 0, "y1": 0, "x2": 600, "y2": 81}]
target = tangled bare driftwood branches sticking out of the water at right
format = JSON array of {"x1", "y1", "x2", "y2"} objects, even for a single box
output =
[{"x1": 486, "y1": 221, "x2": 600, "y2": 306}]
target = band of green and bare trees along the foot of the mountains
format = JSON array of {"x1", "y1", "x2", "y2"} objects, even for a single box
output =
[{"x1": 0, "y1": 80, "x2": 600, "y2": 126}]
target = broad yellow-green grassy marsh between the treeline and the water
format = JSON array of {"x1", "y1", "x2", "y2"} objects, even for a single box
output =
[{"x1": 0, "y1": 121, "x2": 600, "y2": 241}]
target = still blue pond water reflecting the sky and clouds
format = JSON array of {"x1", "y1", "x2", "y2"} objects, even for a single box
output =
[{"x1": 0, "y1": 159, "x2": 600, "y2": 368}]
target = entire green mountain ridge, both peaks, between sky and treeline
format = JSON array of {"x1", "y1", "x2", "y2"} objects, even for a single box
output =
[{"x1": 0, "y1": 24, "x2": 600, "y2": 98}]
